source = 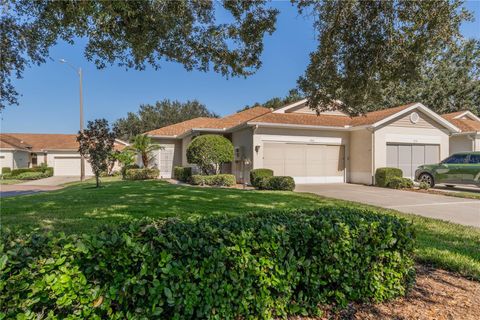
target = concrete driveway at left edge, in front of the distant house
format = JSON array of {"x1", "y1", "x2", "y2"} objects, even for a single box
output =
[{"x1": 0, "y1": 176, "x2": 80, "y2": 198}]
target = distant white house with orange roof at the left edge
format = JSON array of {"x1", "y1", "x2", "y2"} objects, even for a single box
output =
[{"x1": 0, "y1": 133, "x2": 128, "y2": 176}]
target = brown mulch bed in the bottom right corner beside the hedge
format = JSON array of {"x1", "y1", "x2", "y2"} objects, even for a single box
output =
[{"x1": 292, "y1": 266, "x2": 480, "y2": 320}]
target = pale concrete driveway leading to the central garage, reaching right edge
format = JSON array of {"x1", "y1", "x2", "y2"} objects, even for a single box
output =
[{"x1": 295, "y1": 184, "x2": 480, "y2": 228}]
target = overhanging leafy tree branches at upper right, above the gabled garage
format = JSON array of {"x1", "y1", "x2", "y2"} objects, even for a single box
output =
[{"x1": 298, "y1": 0, "x2": 471, "y2": 114}]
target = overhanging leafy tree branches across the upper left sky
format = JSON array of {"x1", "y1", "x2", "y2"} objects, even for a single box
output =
[{"x1": 0, "y1": 0, "x2": 278, "y2": 109}]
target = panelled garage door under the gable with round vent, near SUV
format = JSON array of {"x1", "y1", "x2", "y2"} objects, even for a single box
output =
[{"x1": 387, "y1": 144, "x2": 440, "y2": 178}]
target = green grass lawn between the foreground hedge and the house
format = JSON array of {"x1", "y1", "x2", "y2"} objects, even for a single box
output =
[{"x1": 1, "y1": 178, "x2": 480, "y2": 280}]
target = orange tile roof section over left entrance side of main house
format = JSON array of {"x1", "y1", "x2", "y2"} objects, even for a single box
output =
[{"x1": 146, "y1": 107, "x2": 271, "y2": 136}]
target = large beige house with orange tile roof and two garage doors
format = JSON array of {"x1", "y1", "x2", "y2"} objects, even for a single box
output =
[{"x1": 147, "y1": 100, "x2": 461, "y2": 184}]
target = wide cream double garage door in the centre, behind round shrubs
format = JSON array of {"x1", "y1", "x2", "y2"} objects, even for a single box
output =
[{"x1": 263, "y1": 143, "x2": 345, "y2": 183}]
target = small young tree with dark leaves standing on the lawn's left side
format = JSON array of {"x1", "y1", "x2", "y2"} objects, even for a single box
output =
[{"x1": 77, "y1": 119, "x2": 115, "y2": 188}]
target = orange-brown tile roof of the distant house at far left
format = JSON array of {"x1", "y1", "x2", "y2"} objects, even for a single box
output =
[{"x1": 0, "y1": 133, "x2": 125, "y2": 152}]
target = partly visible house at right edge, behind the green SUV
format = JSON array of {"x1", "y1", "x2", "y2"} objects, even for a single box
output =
[{"x1": 442, "y1": 111, "x2": 480, "y2": 154}]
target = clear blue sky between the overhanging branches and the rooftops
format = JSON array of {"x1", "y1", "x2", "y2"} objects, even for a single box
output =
[{"x1": 1, "y1": 1, "x2": 480, "y2": 133}]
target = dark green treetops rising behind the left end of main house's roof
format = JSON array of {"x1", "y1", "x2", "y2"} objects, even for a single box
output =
[{"x1": 113, "y1": 99, "x2": 218, "y2": 141}]
